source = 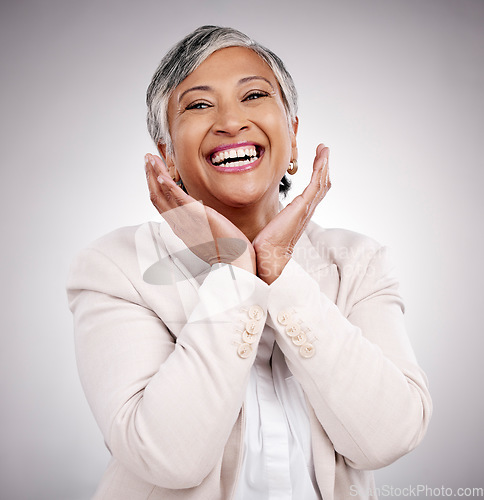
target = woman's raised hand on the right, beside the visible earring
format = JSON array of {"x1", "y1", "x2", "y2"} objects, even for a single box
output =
[{"x1": 252, "y1": 144, "x2": 331, "y2": 284}]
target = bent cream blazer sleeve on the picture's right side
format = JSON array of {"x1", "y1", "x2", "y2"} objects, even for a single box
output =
[{"x1": 268, "y1": 247, "x2": 432, "y2": 470}]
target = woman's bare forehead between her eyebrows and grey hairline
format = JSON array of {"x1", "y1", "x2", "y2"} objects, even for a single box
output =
[{"x1": 174, "y1": 47, "x2": 279, "y2": 96}]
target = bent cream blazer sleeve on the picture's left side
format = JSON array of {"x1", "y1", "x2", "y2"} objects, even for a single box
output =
[{"x1": 68, "y1": 249, "x2": 268, "y2": 489}]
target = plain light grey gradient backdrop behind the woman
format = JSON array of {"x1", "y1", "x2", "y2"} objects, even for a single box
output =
[{"x1": 0, "y1": 0, "x2": 484, "y2": 500}]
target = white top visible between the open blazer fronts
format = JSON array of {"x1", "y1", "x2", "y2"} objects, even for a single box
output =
[{"x1": 234, "y1": 325, "x2": 321, "y2": 500}]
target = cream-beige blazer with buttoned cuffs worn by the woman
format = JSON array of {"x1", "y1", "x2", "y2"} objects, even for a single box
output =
[{"x1": 68, "y1": 222, "x2": 431, "y2": 500}]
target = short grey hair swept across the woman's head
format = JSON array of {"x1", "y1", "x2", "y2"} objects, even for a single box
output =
[{"x1": 146, "y1": 26, "x2": 297, "y2": 153}]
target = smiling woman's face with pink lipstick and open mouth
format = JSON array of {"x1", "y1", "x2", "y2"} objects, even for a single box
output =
[{"x1": 160, "y1": 47, "x2": 297, "y2": 213}]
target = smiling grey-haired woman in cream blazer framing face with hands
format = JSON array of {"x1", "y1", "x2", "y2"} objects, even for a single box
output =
[{"x1": 68, "y1": 26, "x2": 431, "y2": 500}]
